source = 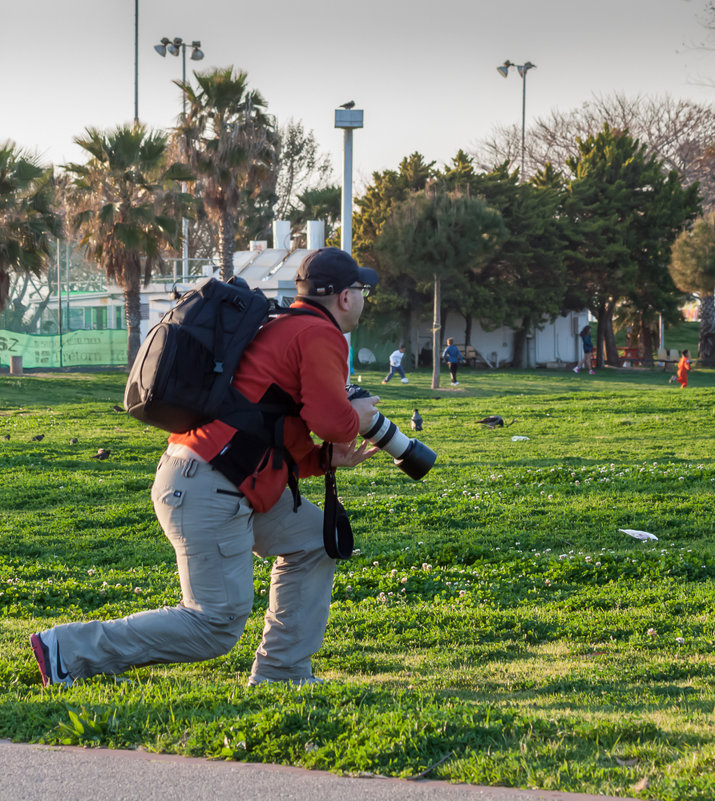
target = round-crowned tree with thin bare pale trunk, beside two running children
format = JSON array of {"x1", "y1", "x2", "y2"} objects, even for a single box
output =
[{"x1": 375, "y1": 188, "x2": 504, "y2": 389}]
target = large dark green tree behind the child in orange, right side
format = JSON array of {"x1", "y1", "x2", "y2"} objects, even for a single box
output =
[{"x1": 565, "y1": 125, "x2": 698, "y2": 365}]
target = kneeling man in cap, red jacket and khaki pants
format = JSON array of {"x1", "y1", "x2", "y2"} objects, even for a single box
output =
[{"x1": 30, "y1": 248, "x2": 379, "y2": 686}]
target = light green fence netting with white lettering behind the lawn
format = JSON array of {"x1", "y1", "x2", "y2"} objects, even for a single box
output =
[{"x1": 0, "y1": 329, "x2": 127, "y2": 369}]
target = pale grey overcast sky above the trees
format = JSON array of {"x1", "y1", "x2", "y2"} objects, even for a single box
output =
[{"x1": 0, "y1": 0, "x2": 715, "y2": 193}]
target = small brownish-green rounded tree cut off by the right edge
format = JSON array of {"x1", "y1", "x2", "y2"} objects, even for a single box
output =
[{"x1": 669, "y1": 212, "x2": 715, "y2": 367}]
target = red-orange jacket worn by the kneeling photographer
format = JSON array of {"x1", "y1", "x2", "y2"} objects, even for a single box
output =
[{"x1": 169, "y1": 300, "x2": 359, "y2": 512}]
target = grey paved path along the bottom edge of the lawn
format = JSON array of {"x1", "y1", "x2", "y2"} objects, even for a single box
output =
[{"x1": 0, "y1": 740, "x2": 627, "y2": 801}]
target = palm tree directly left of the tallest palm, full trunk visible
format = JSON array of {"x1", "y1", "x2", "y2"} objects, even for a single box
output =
[{"x1": 67, "y1": 125, "x2": 191, "y2": 367}]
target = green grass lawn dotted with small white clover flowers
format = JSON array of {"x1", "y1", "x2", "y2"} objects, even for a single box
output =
[{"x1": 0, "y1": 369, "x2": 715, "y2": 801}]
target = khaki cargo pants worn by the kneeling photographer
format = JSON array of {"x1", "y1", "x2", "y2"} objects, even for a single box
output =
[{"x1": 54, "y1": 453, "x2": 335, "y2": 680}]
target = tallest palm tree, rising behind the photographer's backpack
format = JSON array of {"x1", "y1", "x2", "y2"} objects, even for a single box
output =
[{"x1": 176, "y1": 67, "x2": 278, "y2": 281}]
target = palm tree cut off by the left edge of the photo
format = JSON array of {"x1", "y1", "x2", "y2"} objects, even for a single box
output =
[{"x1": 0, "y1": 141, "x2": 61, "y2": 311}]
